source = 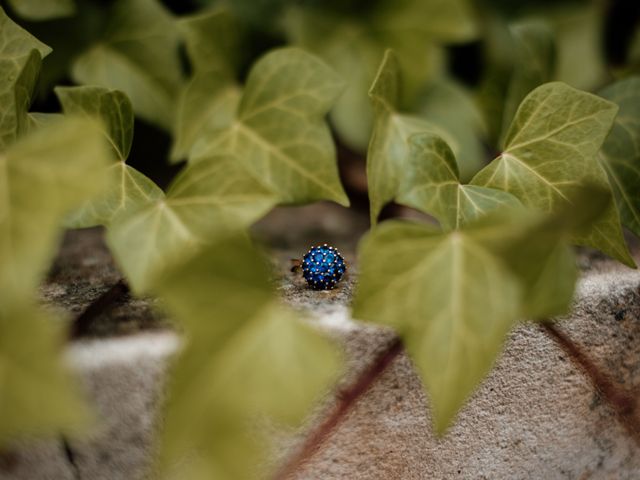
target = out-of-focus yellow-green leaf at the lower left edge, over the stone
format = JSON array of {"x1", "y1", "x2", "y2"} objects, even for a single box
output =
[{"x1": 0, "y1": 300, "x2": 90, "y2": 448}]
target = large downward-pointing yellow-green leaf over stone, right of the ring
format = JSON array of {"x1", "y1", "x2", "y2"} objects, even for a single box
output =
[{"x1": 354, "y1": 221, "x2": 522, "y2": 434}]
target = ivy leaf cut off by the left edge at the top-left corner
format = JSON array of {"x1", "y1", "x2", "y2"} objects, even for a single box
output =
[{"x1": 0, "y1": 8, "x2": 51, "y2": 150}]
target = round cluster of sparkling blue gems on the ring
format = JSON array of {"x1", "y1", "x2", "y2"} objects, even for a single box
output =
[{"x1": 302, "y1": 243, "x2": 347, "y2": 290}]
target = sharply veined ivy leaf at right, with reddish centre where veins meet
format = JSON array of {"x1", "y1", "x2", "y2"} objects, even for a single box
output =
[{"x1": 471, "y1": 82, "x2": 635, "y2": 266}]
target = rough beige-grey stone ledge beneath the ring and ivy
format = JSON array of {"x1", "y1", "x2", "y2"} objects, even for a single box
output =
[{"x1": 0, "y1": 205, "x2": 640, "y2": 480}]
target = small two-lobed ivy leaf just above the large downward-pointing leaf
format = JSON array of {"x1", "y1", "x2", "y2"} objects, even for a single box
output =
[{"x1": 398, "y1": 133, "x2": 522, "y2": 230}]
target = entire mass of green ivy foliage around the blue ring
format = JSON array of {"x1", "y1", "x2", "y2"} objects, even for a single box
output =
[{"x1": 0, "y1": 0, "x2": 640, "y2": 479}]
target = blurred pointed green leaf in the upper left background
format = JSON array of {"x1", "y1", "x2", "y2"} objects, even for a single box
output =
[{"x1": 71, "y1": 0, "x2": 182, "y2": 130}]
